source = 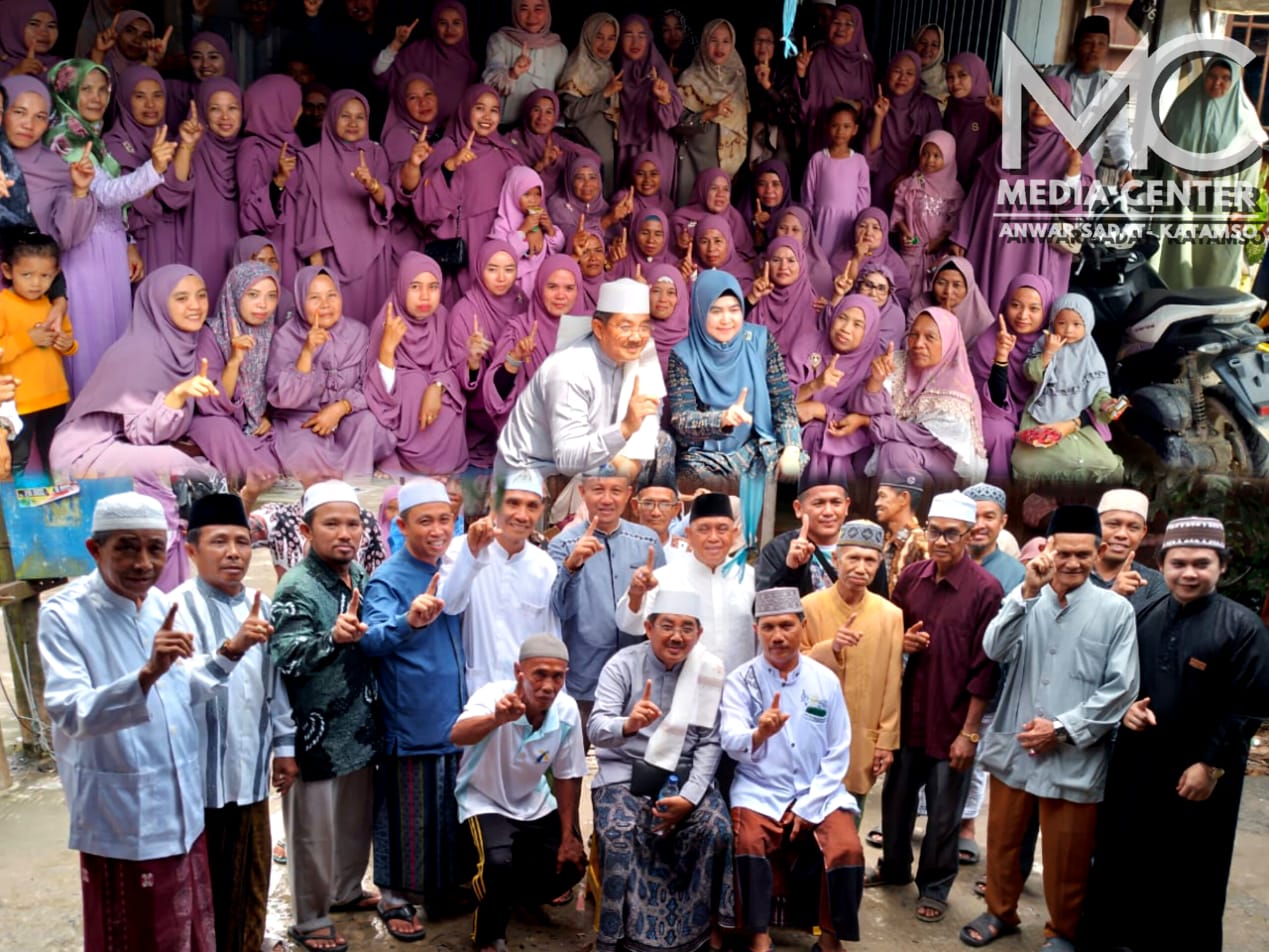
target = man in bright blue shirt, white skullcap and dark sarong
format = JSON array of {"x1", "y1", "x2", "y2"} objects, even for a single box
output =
[{"x1": 360, "y1": 479, "x2": 467, "y2": 939}]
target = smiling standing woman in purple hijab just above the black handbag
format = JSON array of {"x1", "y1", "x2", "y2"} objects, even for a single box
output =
[{"x1": 410, "y1": 84, "x2": 520, "y2": 302}]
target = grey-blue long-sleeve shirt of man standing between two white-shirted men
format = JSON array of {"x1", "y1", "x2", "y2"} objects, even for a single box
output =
[{"x1": 547, "y1": 519, "x2": 665, "y2": 701}]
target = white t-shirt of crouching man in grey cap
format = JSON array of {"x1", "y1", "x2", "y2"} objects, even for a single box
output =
[{"x1": 454, "y1": 680, "x2": 586, "y2": 823}]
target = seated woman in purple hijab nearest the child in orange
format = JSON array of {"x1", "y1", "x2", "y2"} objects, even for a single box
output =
[{"x1": 48, "y1": 264, "x2": 217, "y2": 592}]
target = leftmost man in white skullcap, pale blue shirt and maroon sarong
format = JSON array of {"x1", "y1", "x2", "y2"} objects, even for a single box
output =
[{"x1": 39, "y1": 493, "x2": 236, "y2": 951}]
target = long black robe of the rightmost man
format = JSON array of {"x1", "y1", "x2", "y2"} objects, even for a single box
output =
[{"x1": 1081, "y1": 594, "x2": 1269, "y2": 952}]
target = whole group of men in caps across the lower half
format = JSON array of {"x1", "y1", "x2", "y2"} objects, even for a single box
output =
[{"x1": 39, "y1": 467, "x2": 1269, "y2": 952}]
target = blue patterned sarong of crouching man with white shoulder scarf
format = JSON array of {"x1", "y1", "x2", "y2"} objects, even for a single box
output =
[{"x1": 594, "y1": 783, "x2": 736, "y2": 952}]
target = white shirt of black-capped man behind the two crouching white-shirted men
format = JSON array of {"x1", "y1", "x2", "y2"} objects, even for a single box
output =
[{"x1": 617, "y1": 563, "x2": 758, "y2": 674}]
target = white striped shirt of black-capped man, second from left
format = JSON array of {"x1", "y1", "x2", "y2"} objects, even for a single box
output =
[{"x1": 170, "y1": 578, "x2": 296, "y2": 810}]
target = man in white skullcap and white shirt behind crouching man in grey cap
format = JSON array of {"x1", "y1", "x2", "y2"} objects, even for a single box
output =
[{"x1": 437, "y1": 470, "x2": 560, "y2": 694}]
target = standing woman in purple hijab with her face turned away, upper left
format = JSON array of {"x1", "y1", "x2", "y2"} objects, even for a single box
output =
[{"x1": 233, "y1": 75, "x2": 305, "y2": 287}]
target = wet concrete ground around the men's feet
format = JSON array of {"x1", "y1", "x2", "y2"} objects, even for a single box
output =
[{"x1": 0, "y1": 484, "x2": 1269, "y2": 952}]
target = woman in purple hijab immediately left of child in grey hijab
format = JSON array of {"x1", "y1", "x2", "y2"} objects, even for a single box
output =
[{"x1": 970, "y1": 274, "x2": 1053, "y2": 485}]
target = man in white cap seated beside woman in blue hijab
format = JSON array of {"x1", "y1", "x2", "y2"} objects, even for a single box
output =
[{"x1": 485, "y1": 278, "x2": 665, "y2": 479}]
